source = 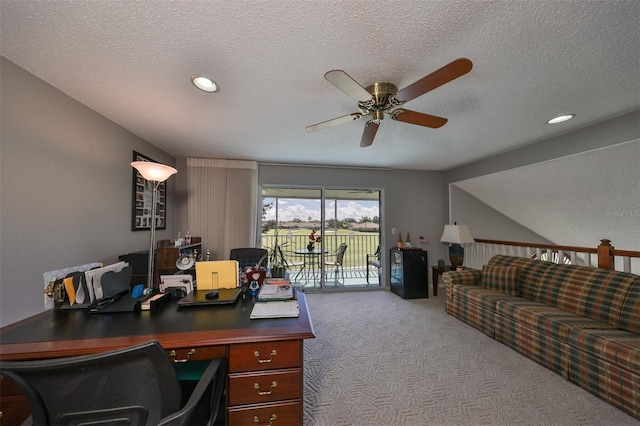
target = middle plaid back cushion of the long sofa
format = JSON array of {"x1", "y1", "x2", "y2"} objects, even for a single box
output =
[{"x1": 533, "y1": 265, "x2": 638, "y2": 327}]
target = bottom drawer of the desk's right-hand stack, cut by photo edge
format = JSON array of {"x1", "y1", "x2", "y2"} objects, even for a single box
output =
[{"x1": 228, "y1": 401, "x2": 302, "y2": 426}]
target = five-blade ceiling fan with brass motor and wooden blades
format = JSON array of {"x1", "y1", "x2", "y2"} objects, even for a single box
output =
[{"x1": 306, "y1": 58, "x2": 473, "y2": 147}]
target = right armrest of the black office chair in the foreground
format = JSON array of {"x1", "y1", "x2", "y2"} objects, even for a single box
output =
[{"x1": 159, "y1": 357, "x2": 227, "y2": 426}]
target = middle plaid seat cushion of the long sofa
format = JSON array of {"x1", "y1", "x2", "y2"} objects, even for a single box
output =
[{"x1": 496, "y1": 299, "x2": 614, "y2": 343}]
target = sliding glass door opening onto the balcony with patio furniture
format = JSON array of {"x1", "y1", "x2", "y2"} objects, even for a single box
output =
[{"x1": 260, "y1": 186, "x2": 383, "y2": 290}]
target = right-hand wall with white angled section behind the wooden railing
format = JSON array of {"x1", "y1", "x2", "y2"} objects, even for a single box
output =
[{"x1": 445, "y1": 111, "x2": 640, "y2": 250}]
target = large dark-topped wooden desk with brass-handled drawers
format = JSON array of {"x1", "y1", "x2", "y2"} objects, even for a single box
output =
[{"x1": 0, "y1": 292, "x2": 315, "y2": 425}]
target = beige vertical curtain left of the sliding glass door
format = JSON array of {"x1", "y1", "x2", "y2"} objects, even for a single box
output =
[{"x1": 187, "y1": 158, "x2": 258, "y2": 260}]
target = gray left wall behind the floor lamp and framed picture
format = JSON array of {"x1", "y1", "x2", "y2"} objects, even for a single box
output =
[{"x1": 0, "y1": 58, "x2": 180, "y2": 325}]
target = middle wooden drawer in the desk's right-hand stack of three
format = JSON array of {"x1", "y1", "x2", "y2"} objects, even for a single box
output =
[{"x1": 229, "y1": 369, "x2": 301, "y2": 406}]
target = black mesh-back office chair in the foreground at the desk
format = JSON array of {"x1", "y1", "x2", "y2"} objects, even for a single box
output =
[{"x1": 0, "y1": 340, "x2": 227, "y2": 426}]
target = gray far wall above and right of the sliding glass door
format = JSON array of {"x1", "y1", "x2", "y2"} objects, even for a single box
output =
[{"x1": 258, "y1": 165, "x2": 447, "y2": 286}]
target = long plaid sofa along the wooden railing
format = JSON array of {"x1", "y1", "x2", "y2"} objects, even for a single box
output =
[{"x1": 443, "y1": 255, "x2": 640, "y2": 420}]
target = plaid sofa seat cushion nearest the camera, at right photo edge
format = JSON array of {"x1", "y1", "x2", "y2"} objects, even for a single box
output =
[{"x1": 569, "y1": 329, "x2": 640, "y2": 374}]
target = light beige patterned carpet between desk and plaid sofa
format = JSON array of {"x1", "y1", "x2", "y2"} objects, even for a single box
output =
[{"x1": 304, "y1": 289, "x2": 639, "y2": 426}]
